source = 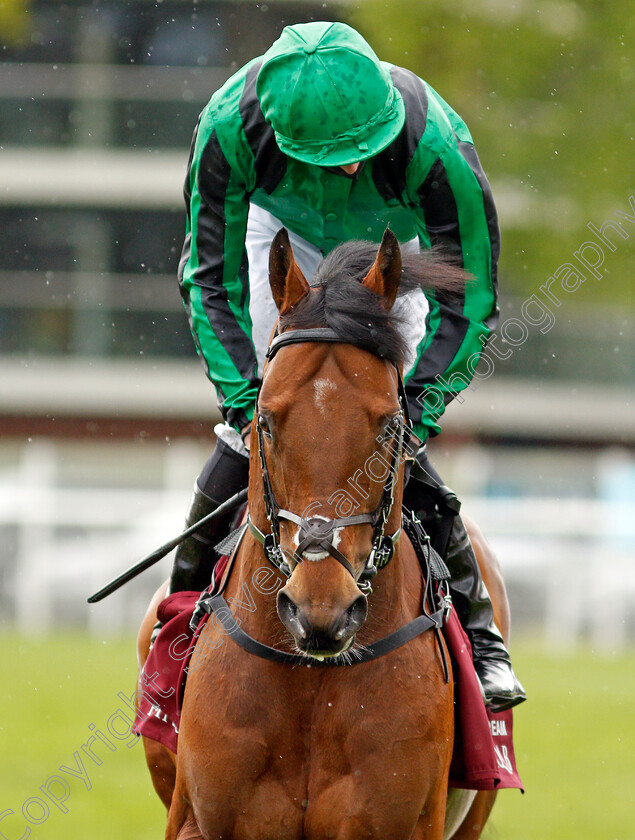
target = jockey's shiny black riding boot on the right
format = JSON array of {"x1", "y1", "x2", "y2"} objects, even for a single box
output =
[{"x1": 404, "y1": 450, "x2": 526, "y2": 712}]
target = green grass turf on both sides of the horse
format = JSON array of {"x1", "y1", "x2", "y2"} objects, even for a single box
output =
[{"x1": 0, "y1": 634, "x2": 635, "y2": 840}]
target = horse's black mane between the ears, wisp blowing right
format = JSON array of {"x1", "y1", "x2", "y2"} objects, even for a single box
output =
[{"x1": 280, "y1": 240, "x2": 466, "y2": 364}]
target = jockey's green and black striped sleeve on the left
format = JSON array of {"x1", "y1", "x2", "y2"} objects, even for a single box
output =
[{"x1": 179, "y1": 97, "x2": 258, "y2": 429}]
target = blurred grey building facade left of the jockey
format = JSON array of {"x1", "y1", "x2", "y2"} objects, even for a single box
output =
[{"x1": 0, "y1": 0, "x2": 346, "y2": 435}]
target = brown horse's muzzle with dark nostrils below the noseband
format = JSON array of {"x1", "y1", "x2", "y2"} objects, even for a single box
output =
[{"x1": 277, "y1": 587, "x2": 368, "y2": 656}]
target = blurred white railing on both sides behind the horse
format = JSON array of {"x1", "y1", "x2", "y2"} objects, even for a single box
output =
[{"x1": 0, "y1": 441, "x2": 635, "y2": 650}]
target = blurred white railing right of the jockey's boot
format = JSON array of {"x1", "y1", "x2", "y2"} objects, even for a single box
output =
[{"x1": 464, "y1": 498, "x2": 635, "y2": 650}]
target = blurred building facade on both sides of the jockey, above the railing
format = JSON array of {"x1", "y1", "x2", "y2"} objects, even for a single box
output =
[{"x1": 0, "y1": 0, "x2": 635, "y2": 445}]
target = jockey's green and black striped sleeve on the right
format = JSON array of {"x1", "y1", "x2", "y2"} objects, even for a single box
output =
[{"x1": 406, "y1": 86, "x2": 500, "y2": 439}]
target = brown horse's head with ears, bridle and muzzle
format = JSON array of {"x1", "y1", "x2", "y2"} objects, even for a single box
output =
[{"x1": 250, "y1": 229, "x2": 407, "y2": 659}]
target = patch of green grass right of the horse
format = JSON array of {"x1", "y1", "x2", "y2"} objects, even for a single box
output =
[{"x1": 492, "y1": 644, "x2": 635, "y2": 840}]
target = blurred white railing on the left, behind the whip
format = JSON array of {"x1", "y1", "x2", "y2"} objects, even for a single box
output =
[{"x1": 0, "y1": 440, "x2": 204, "y2": 632}]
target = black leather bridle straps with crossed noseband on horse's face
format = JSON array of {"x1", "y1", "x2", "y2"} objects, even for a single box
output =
[{"x1": 248, "y1": 327, "x2": 412, "y2": 594}]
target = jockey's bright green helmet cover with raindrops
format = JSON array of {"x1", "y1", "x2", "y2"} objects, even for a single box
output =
[{"x1": 256, "y1": 22, "x2": 405, "y2": 166}]
